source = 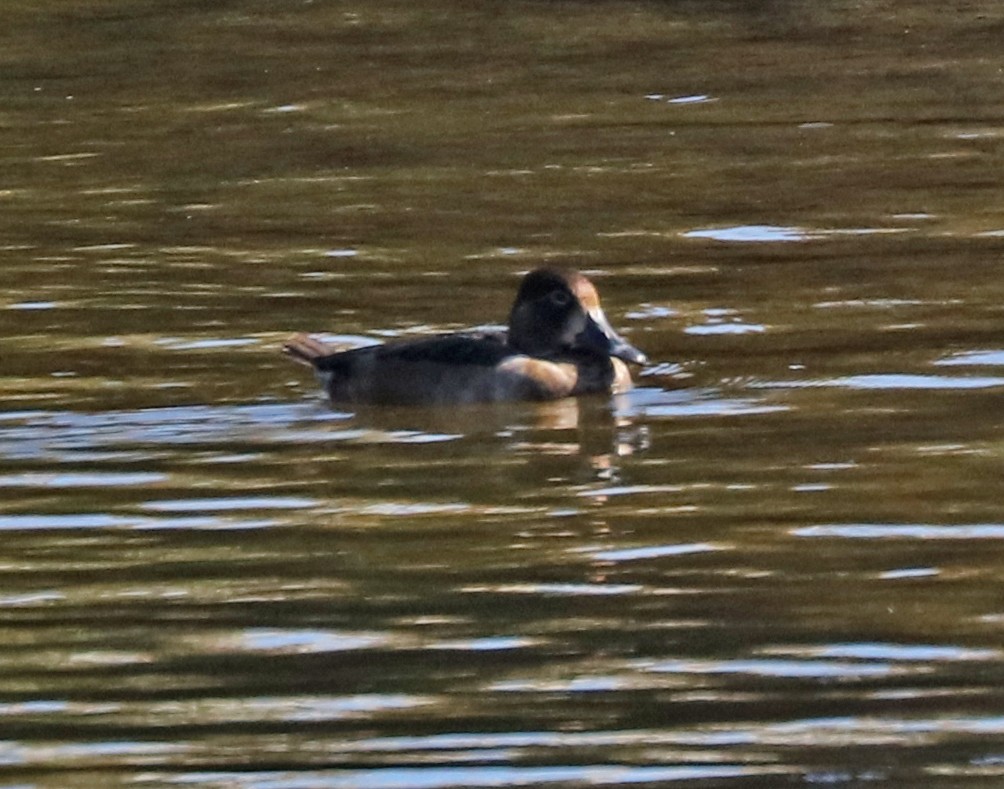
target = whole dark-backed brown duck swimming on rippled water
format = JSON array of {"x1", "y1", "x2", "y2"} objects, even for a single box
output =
[{"x1": 283, "y1": 267, "x2": 649, "y2": 406}]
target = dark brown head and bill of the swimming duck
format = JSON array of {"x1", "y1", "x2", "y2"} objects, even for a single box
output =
[{"x1": 509, "y1": 268, "x2": 649, "y2": 364}]
